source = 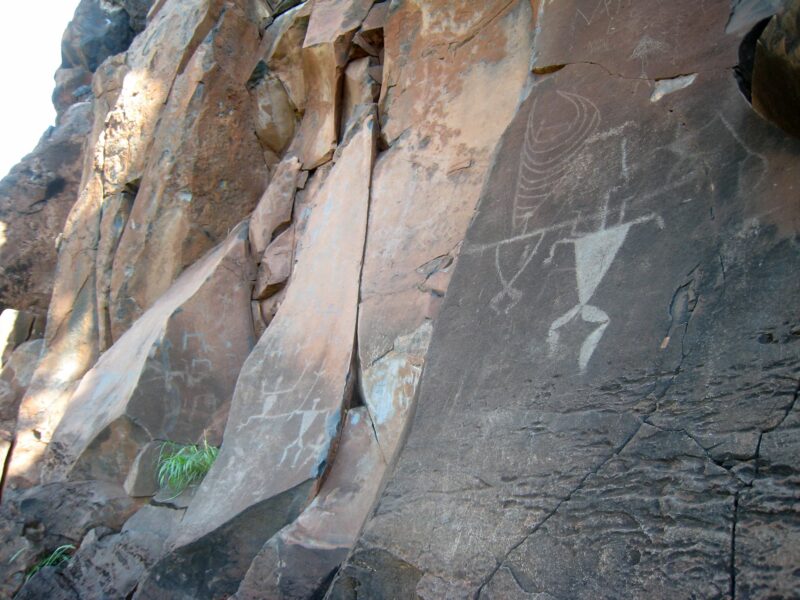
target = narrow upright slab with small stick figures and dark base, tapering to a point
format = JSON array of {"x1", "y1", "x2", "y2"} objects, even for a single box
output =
[{"x1": 137, "y1": 110, "x2": 376, "y2": 598}]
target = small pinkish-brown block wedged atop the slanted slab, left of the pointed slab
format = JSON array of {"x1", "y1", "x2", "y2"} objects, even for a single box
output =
[{"x1": 250, "y1": 156, "x2": 300, "y2": 258}]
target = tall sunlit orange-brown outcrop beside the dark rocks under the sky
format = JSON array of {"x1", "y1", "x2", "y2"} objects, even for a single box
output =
[{"x1": 7, "y1": 0, "x2": 267, "y2": 486}]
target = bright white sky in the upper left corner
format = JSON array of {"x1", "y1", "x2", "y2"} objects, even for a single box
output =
[{"x1": 0, "y1": 0, "x2": 78, "y2": 178}]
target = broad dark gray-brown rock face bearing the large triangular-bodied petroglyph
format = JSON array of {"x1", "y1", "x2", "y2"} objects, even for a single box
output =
[{"x1": 328, "y1": 0, "x2": 800, "y2": 599}]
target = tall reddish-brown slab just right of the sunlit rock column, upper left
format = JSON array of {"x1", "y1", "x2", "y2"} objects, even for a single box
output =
[{"x1": 108, "y1": 6, "x2": 269, "y2": 340}]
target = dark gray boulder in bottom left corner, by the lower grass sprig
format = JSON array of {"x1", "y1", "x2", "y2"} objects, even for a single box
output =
[{"x1": 0, "y1": 481, "x2": 138, "y2": 598}]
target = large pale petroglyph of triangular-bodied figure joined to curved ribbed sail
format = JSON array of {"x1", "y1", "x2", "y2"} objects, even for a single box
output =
[{"x1": 476, "y1": 91, "x2": 664, "y2": 372}]
